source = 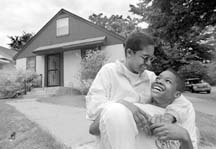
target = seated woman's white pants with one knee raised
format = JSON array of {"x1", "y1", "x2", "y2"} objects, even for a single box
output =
[{"x1": 97, "y1": 103, "x2": 164, "y2": 149}]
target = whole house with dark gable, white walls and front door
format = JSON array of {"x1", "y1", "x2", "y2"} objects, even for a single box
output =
[{"x1": 15, "y1": 9, "x2": 124, "y2": 87}]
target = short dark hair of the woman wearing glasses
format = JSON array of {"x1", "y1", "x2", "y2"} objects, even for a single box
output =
[{"x1": 124, "y1": 31, "x2": 154, "y2": 53}]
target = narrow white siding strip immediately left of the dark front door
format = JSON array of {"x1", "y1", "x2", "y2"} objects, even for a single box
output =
[{"x1": 36, "y1": 56, "x2": 45, "y2": 86}]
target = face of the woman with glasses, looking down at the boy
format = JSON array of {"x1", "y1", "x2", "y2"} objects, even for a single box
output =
[{"x1": 126, "y1": 45, "x2": 154, "y2": 74}]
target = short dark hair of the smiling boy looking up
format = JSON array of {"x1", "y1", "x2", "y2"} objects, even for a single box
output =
[{"x1": 166, "y1": 68, "x2": 185, "y2": 92}]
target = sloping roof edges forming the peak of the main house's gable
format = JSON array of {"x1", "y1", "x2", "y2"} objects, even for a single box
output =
[{"x1": 14, "y1": 9, "x2": 125, "y2": 59}]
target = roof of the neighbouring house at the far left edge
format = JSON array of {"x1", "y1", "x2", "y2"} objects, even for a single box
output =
[{"x1": 0, "y1": 46, "x2": 17, "y2": 61}]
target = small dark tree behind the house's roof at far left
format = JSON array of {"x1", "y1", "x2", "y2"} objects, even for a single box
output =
[{"x1": 8, "y1": 32, "x2": 33, "y2": 51}]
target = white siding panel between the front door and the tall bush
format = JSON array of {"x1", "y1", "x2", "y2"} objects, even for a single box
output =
[{"x1": 64, "y1": 50, "x2": 81, "y2": 88}]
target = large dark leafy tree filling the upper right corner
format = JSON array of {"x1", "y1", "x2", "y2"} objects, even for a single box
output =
[{"x1": 130, "y1": 0, "x2": 216, "y2": 69}]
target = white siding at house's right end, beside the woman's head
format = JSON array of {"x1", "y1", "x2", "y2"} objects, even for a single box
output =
[{"x1": 102, "y1": 44, "x2": 125, "y2": 62}]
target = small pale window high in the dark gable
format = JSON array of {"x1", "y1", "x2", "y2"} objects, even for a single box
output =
[{"x1": 56, "y1": 18, "x2": 69, "y2": 36}]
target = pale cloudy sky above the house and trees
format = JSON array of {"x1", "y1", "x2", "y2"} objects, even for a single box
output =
[{"x1": 0, "y1": 0, "x2": 143, "y2": 48}]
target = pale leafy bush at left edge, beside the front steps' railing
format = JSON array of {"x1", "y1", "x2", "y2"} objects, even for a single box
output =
[{"x1": 0, "y1": 71, "x2": 38, "y2": 98}]
